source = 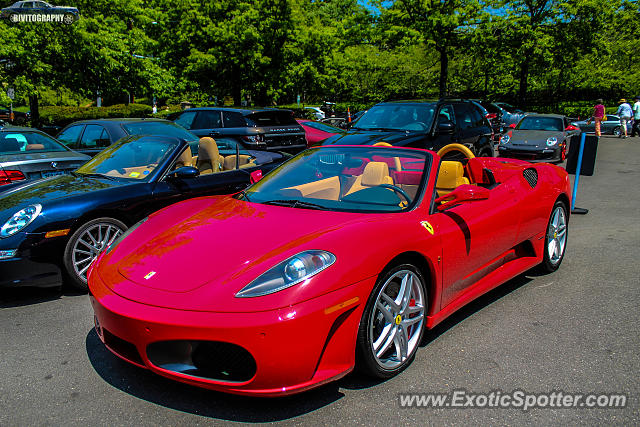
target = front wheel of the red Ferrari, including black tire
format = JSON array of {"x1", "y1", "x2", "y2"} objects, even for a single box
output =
[{"x1": 357, "y1": 264, "x2": 427, "y2": 378}]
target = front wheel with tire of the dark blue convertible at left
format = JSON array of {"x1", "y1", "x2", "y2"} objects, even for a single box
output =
[{"x1": 63, "y1": 218, "x2": 127, "y2": 291}]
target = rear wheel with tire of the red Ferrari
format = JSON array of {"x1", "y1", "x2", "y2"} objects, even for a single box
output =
[{"x1": 540, "y1": 200, "x2": 569, "y2": 273}]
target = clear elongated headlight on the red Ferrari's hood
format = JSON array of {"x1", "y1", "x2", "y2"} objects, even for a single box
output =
[{"x1": 236, "y1": 250, "x2": 336, "y2": 298}]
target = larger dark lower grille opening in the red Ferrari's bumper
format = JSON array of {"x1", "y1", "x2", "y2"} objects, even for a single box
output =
[{"x1": 147, "y1": 340, "x2": 257, "y2": 382}]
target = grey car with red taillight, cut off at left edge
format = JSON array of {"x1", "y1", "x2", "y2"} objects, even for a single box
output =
[{"x1": 0, "y1": 126, "x2": 90, "y2": 187}]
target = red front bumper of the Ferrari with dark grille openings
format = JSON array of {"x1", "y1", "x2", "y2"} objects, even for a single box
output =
[{"x1": 90, "y1": 272, "x2": 375, "y2": 396}]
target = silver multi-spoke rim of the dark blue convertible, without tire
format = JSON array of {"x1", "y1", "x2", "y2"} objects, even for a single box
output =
[{"x1": 71, "y1": 222, "x2": 124, "y2": 283}]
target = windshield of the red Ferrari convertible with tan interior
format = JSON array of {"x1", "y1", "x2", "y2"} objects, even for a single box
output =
[{"x1": 236, "y1": 146, "x2": 431, "y2": 212}]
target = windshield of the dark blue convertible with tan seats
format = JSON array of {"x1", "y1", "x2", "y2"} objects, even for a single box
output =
[{"x1": 76, "y1": 137, "x2": 180, "y2": 180}]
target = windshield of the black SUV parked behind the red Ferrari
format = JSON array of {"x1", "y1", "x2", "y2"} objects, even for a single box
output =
[{"x1": 352, "y1": 104, "x2": 435, "y2": 131}]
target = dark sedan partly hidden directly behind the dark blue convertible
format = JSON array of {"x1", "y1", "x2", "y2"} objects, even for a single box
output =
[{"x1": 57, "y1": 119, "x2": 198, "y2": 156}]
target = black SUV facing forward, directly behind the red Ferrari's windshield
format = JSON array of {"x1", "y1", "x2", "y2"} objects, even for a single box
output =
[{"x1": 323, "y1": 99, "x2": 493, "y2": 157}]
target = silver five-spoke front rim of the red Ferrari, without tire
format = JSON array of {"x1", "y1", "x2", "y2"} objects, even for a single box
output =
[{"x1": 368, "y1": 269, "x2": 425, "y2": 370}]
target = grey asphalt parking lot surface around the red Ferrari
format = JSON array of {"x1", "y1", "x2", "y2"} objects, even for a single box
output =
[{"x1": 0, "y1": 137, "x2": 640, "y2": 426}]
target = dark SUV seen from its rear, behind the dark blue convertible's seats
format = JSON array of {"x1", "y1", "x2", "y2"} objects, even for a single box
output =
[{"x1": 172, "y1": 107, "x2": 307, "y2": 152}]
